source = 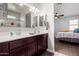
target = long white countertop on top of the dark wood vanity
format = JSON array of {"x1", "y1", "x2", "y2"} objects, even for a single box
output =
[{"x1": 0, "y1": 31, "x2": 48, "y2": 43}]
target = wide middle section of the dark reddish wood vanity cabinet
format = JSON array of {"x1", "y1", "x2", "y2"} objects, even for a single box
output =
[{"x1": 10, "y1": 37, "x2": 37, "y2": 56}]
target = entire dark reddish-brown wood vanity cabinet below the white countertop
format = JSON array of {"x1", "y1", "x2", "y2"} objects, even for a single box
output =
[{"x1": 0, "y1": 34, "x2": 48, "y2": 56}]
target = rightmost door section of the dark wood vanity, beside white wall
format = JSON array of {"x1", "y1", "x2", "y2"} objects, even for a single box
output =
[{"x1": 37, "y1": 34, "x2": 48, "y2": 55}]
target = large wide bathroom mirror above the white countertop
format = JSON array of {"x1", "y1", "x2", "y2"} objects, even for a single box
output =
[{"x1": 0, "y1": 3, "x2": 45, "y2": 28}]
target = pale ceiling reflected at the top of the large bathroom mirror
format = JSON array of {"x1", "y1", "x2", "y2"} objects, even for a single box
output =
[{"x1": 8, "y1": 3, "x2": 29, "y2": 13}]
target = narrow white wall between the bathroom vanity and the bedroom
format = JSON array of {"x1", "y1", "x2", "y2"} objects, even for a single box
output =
[{"x1": 41, "y1": 3, "x2": 54, "y2": 52}]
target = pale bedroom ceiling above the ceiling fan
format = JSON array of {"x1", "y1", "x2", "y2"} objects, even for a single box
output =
[{"x1": 54, "y1": 3, "x2": 79, "y2": 17}]
